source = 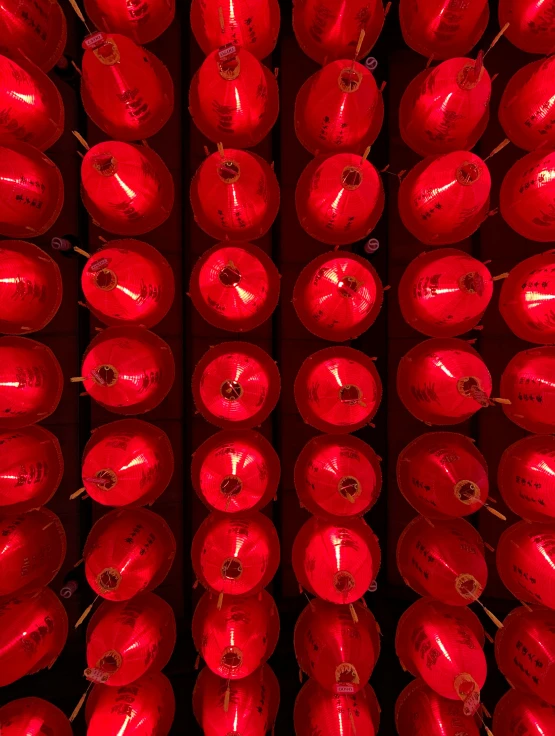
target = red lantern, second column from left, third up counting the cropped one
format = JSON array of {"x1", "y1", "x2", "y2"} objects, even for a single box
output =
[{"x1": 83, "y1": 509, "x2": 176, "y2": 601}]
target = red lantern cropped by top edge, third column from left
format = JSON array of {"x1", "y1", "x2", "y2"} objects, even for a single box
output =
[{"x1": 191, "y1": 0, "x2": 280, "y2": 59}]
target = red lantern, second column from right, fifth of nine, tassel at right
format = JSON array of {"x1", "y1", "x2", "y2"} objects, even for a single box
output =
[{"x1": 397, "y1": 338, "x2": 491, "y2": 424}]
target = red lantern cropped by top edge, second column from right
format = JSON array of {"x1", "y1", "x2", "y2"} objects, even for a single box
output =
[{"x1": 399, "y1": 0, "x2": 489, "y2": 59}]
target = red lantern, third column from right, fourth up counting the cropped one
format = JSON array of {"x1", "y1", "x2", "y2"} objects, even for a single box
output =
[{"x1": 295, "y1": 434, "x2": 382, "y2": 518}]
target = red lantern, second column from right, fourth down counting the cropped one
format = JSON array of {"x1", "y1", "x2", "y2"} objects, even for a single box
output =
[{"x1": 399, "y1": 248, "x2": 493, "y2": 337}]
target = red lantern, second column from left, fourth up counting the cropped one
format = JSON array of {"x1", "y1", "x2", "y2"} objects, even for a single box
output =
[{"x1": 81, "y1": 419, "x2": 174, "y2": 506}]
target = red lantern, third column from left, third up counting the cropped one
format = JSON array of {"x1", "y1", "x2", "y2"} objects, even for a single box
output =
[{"x1": 191, "y1": 512, "x2": 279, "y2": 606}]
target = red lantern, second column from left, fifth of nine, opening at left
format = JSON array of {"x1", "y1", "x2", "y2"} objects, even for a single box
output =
[{"x1": 82, "y1": 327, "x2": 175, "y2": 414}]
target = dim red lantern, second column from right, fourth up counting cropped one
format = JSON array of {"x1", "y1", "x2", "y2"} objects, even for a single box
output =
[{"x1": 397, "y1": 432, "x2": 489, "y2": 520}]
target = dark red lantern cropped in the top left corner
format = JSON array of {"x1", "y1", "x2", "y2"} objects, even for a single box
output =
[{"x1": 0, "y1": 0, "x2": 67, "y2": 72}]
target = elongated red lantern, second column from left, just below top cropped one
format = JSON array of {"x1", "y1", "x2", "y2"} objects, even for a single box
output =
[{"x1": 81, "y1": 32, "x2": 173, "y2": 141}]
